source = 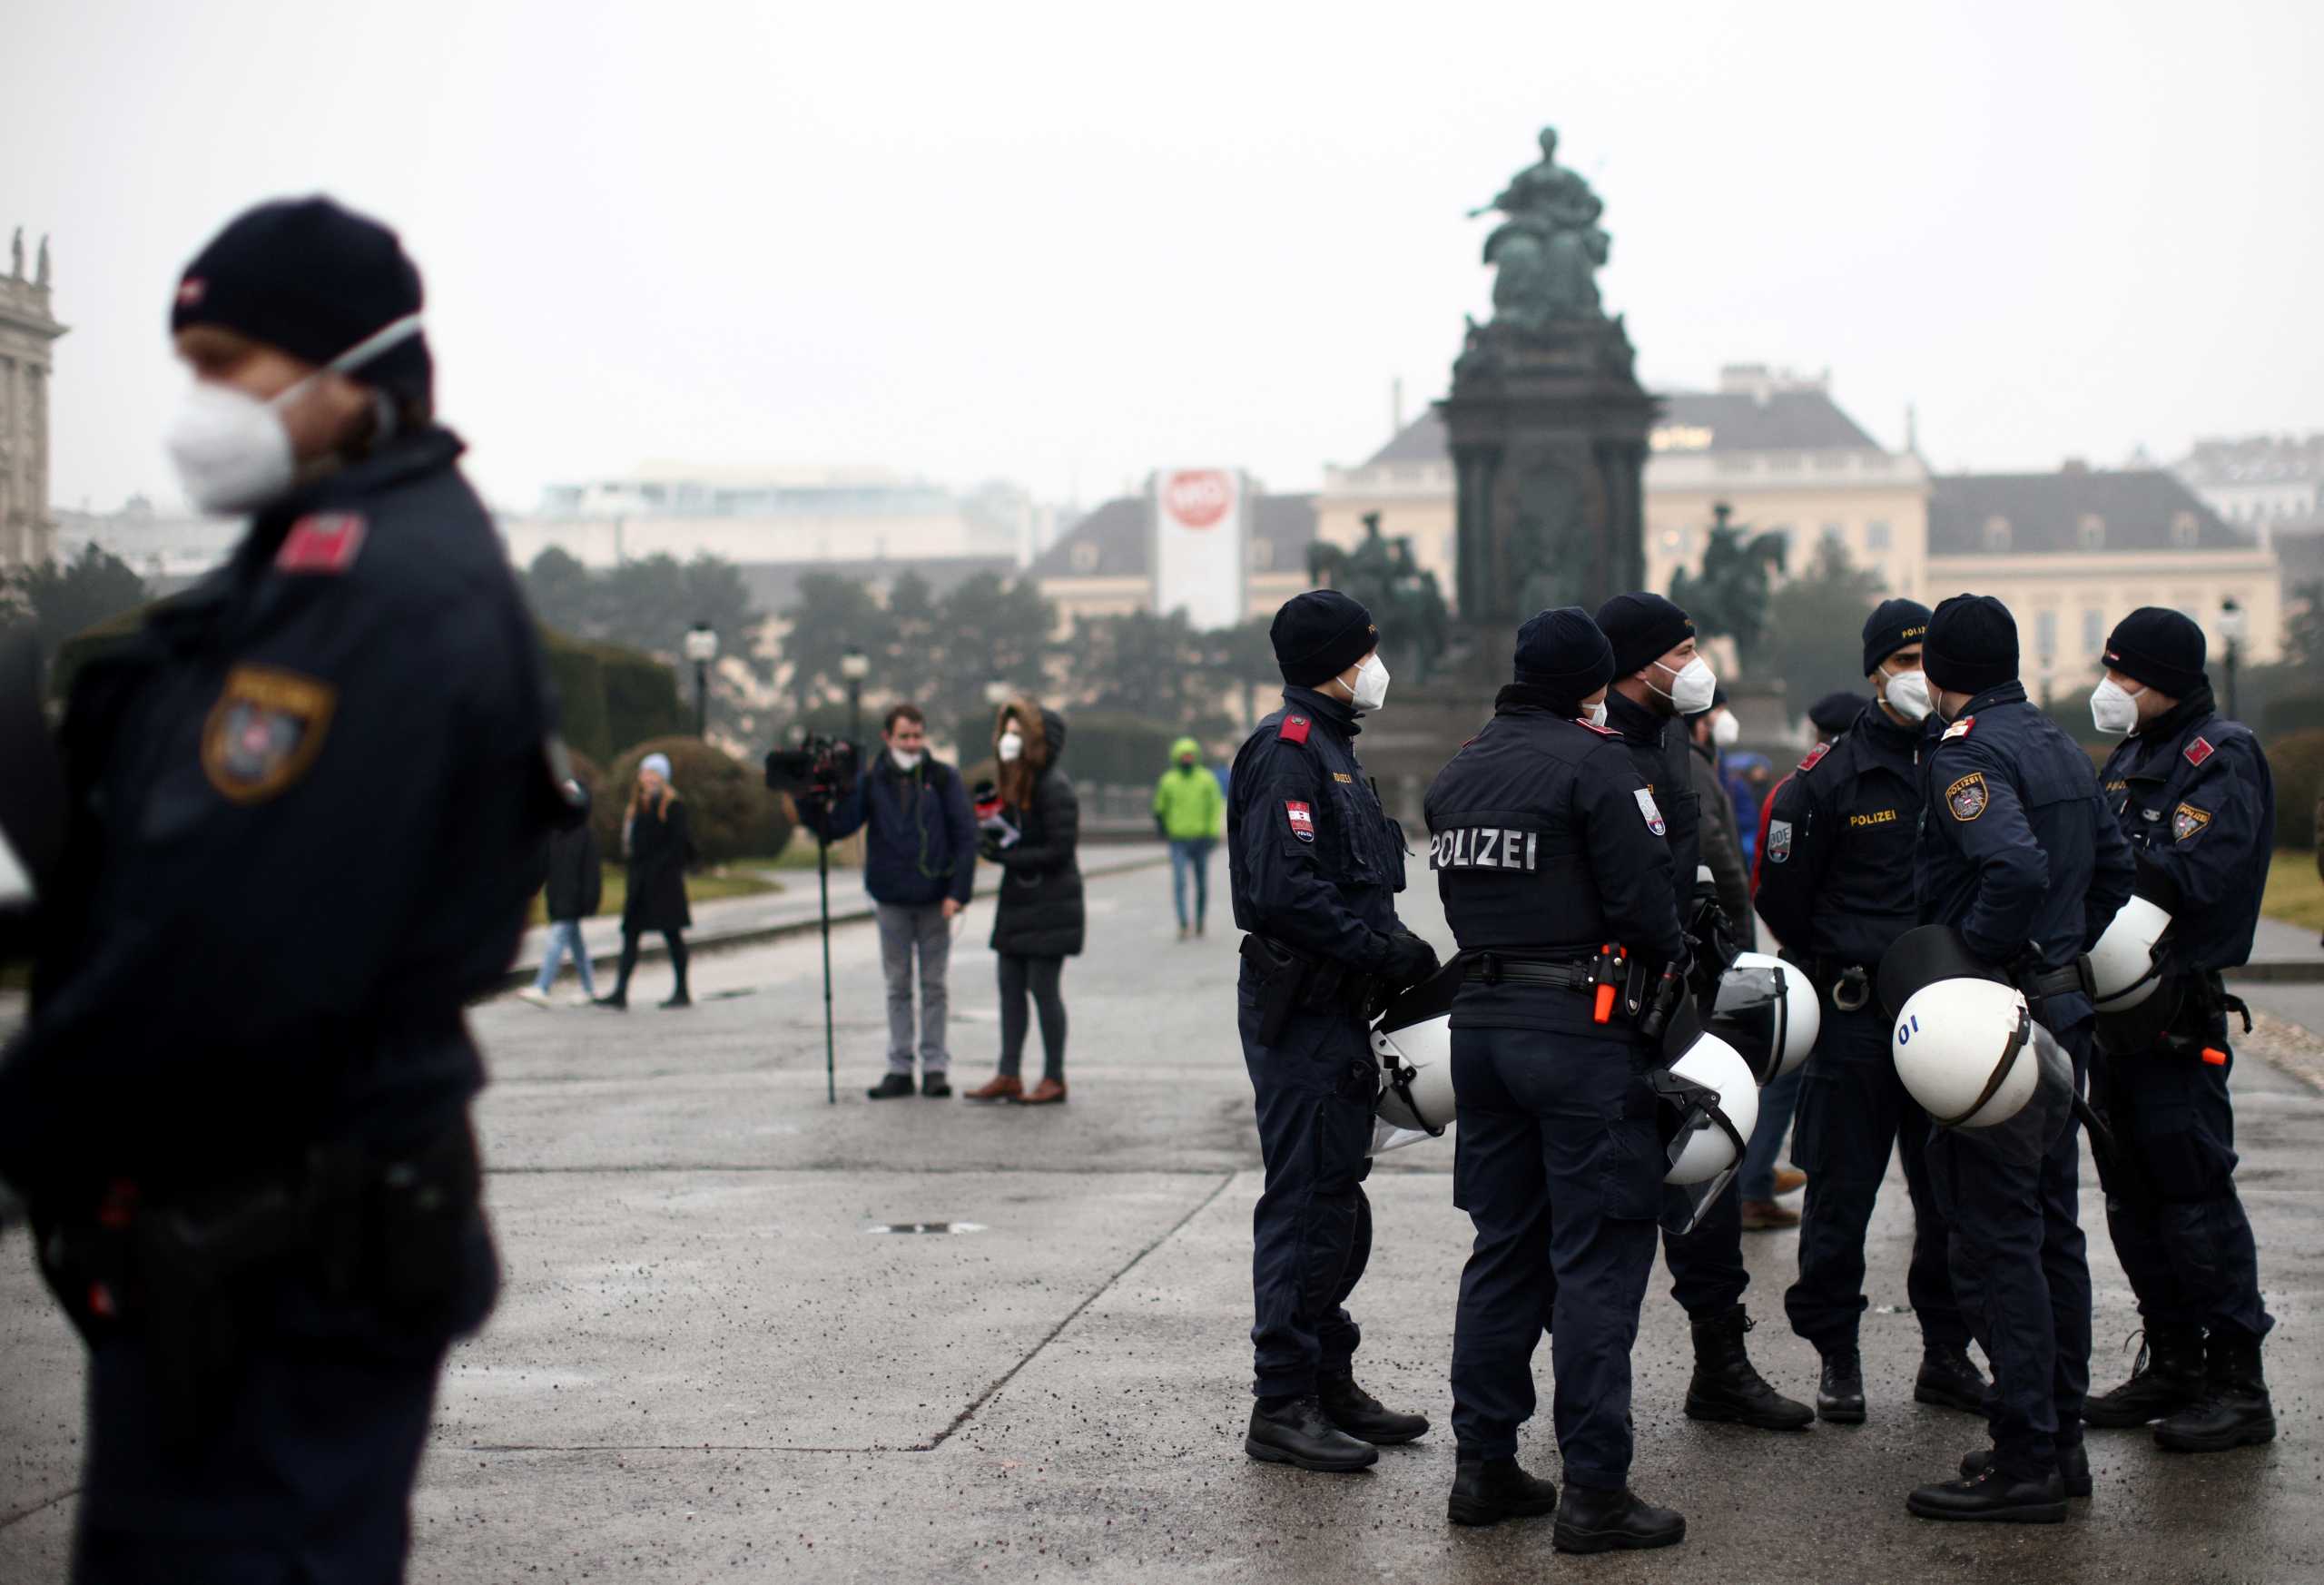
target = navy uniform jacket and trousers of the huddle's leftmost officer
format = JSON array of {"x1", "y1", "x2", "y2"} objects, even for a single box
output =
[{"x1": 1227, "y1": 688, "x2": 1403, "y2": 1397}]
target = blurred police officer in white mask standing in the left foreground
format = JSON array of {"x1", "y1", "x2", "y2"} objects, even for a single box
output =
[{"x1": 0, "y1": 198, "x2": 563, "y2": 1580}]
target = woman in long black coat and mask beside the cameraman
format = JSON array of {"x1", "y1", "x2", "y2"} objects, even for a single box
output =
[{"x1": 967, "y1": 700, "x2": 1083, "y2": 1107}]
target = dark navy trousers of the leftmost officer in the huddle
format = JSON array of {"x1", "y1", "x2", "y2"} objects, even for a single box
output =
[{"x1": 1236, "y1": 971, "x2": 1381, "y2": 1397}]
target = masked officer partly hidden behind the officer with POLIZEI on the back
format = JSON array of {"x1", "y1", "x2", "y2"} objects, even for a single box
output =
[{"x1": 1597, "y1": 593, "x2": 1815, "y2": 1432}]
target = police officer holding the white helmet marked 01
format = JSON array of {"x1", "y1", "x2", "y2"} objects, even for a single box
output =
[{"x1": 1896, "y1": 595, "x2": 2132, "y2": 1524}]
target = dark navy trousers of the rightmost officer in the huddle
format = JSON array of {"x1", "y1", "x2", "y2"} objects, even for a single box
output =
[{"x1": 2089, "y1": 1028, "x2": 2275, "y2": 1336}]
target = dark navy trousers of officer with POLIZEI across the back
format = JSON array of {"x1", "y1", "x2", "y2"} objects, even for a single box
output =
[{"x1": 1452, "y1": 1029, "x2": 1664, "y2": 1490}]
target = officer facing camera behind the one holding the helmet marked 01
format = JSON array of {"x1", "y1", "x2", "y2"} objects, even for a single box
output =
[{"x1": 1755, "y1": 600, "x2": 1984, "y2": 1424}]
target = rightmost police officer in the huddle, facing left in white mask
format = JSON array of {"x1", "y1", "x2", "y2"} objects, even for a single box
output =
[{"x1": 2083, "y1": 606, "x2": 2275, "y2": 1452}]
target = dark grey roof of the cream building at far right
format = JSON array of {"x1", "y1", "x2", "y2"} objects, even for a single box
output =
[{"x1": 1929, "y1": 469, "x2": 2257, "y2": 556}]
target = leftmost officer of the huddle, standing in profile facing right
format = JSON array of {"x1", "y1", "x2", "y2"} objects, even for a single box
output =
[{"x1": 1227, "y1": 588, "x2": 1436, "y2": 1472}]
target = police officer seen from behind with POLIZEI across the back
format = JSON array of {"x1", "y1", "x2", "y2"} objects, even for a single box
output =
[{"x1": 1427, "y1": 606, "x2": 1688, "y2": 1552}]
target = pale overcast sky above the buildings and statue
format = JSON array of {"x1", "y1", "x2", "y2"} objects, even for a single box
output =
[{"x1": 0, "y1": 0, "x2": 2324, "y2": 509}]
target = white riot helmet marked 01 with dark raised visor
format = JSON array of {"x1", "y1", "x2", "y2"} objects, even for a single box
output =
[{"x1": 1880, "y1": 925, "x2": 2075, "y2": 1129}]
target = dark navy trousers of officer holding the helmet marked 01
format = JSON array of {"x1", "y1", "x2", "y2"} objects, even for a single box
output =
[{"x1": 1929, "y1": 1018, "x2": 2092, "y2": 1481}]
